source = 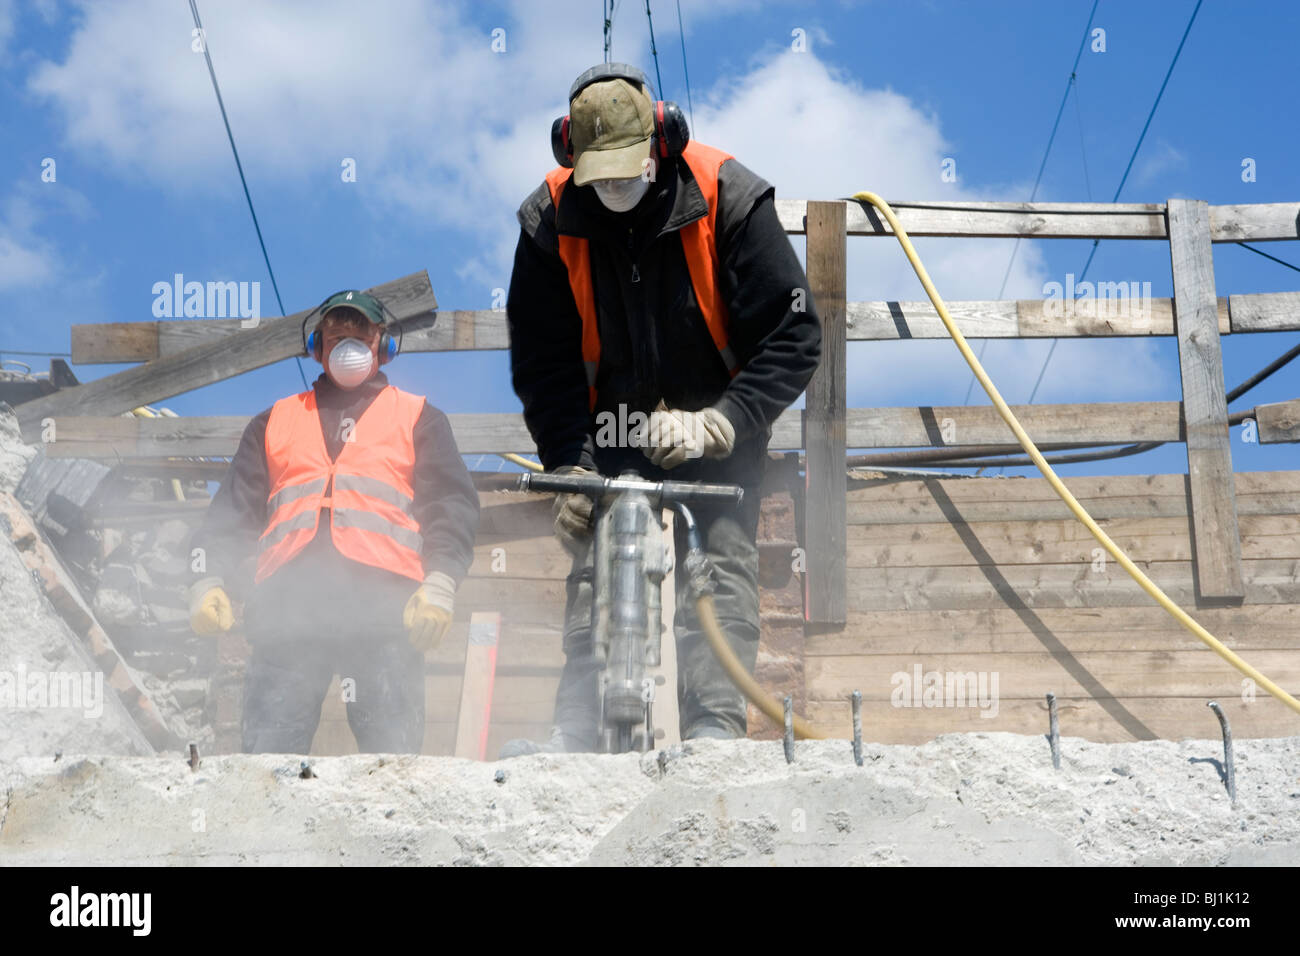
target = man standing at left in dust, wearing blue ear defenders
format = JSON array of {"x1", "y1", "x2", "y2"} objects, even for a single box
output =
[{"x1": 190, "y1": 290, "x2": 478, "y2": 753}]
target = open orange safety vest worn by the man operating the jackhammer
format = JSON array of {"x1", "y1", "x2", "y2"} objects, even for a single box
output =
[{"x1": 546, "y1": 139, "x2": 740, "y2": 408}]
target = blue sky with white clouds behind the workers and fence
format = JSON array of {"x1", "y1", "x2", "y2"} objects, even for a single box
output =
[{"x1": 0, "y1": 0, "x2": 1300, "y2": 475}]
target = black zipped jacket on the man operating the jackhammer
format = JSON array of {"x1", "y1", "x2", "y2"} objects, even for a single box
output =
[{"x1": 506, "y1": 145, "x2": 822, "y2": 485}]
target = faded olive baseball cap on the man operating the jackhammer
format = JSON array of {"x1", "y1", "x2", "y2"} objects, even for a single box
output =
[{"x1": 569, "y1": 78, "x2": 654, "y2": 186}]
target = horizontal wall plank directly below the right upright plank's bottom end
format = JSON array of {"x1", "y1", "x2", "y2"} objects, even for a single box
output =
[{"x1": 803, "y1": 604, "x2": 1300, "y2": 659}]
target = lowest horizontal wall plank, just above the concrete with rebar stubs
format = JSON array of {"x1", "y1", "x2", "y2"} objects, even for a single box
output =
[{"x1": 806, "y1": 695, "x2": 1296, "y2": 749}]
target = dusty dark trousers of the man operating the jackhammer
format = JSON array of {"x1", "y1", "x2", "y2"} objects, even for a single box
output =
[{"x1": 554, "y1": 488, "x2": 759, "y2": 752}]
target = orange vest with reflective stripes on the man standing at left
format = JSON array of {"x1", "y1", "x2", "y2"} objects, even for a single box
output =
[{"x1": 255, "y1": 385, "x2": 424, "y2": 584}]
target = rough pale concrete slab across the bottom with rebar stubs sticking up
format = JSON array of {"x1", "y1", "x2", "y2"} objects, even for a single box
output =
[{"x1": 0, "y1": 734, "x2": 1300, "y2": 866}]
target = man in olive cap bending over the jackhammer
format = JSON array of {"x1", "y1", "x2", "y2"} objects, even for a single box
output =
[{"x1": 502, "y1": 64, "x2": 822, "y2": 756}]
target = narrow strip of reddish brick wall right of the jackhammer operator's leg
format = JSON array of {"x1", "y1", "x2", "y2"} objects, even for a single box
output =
[{"x1": 749, "y1": 457, "x2": 805, "y2": 740}]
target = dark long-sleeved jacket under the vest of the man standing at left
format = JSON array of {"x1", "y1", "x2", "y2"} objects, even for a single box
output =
[{"x1": 192, "y1": 372, "x2": 478, "y2": 633}]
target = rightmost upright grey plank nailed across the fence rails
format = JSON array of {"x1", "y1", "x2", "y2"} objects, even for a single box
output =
[{"x1": 1169, "y1": 199, "x2": 1245, "y2": 601}]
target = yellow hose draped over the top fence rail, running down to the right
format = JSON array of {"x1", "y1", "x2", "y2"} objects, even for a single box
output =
[{"x1": 853, "y1": 193, "x2": 1300, "y2": 714}]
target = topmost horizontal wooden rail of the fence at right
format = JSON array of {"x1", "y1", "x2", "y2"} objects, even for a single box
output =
[{"x1": 776, "y1": 199, "x2": 1300, "y2": 242}]
